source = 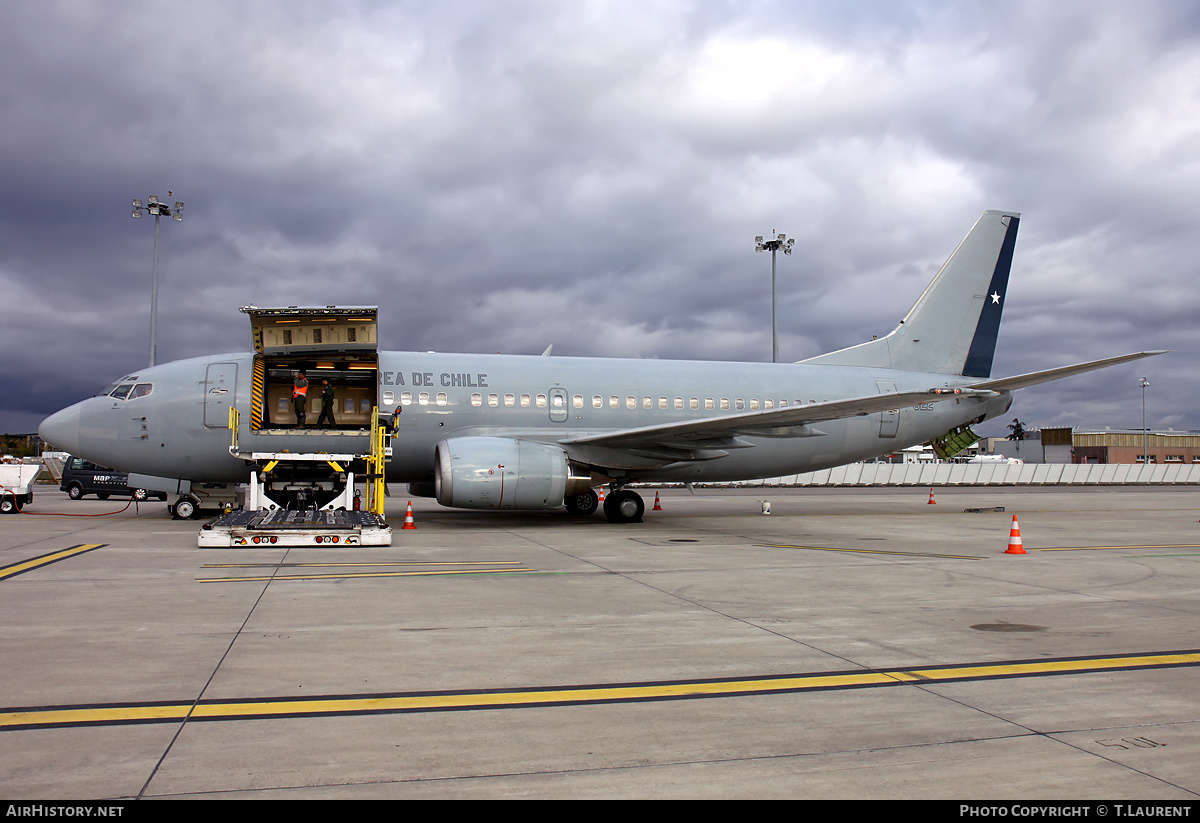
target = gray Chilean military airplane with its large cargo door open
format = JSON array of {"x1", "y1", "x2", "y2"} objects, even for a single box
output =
[{"x1": 38, "y1": 211, "x2": 1160, "y2": 522}]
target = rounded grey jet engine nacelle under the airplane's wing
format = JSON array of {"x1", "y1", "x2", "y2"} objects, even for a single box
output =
[{"x1": 433, "y1": 437, "x2": 590, "y2": 509}]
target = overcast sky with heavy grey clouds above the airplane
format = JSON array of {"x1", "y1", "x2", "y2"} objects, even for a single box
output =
[{"x1": 0, "y1": 0, "x2": 1200, "y2": 434}]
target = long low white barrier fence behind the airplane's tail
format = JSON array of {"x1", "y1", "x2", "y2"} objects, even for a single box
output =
[{"x1": 722, "y1": 463, "x2": 1200, "y2": 486}]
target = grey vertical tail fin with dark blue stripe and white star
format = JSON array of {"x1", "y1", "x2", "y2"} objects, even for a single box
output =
[{"x1": 800, "y1": 211, "x2": 1021, "y2": 377}]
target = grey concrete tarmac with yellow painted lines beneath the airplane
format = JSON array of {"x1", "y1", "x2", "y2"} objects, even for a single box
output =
[{"x1": 0, "y1": 486, "x2": 1200, "y2": 805}]
